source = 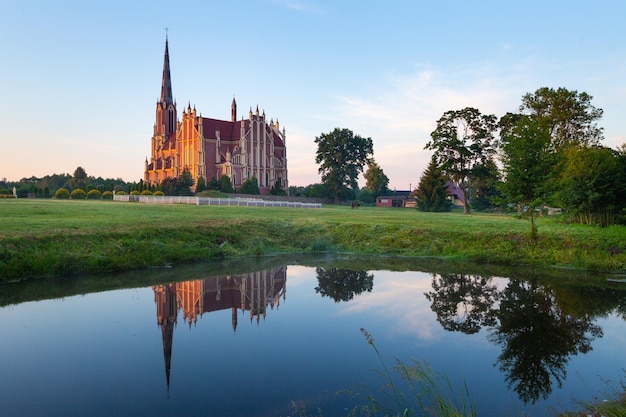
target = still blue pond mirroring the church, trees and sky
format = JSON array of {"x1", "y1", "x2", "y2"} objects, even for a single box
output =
[{"x1": 0, "y1": 260, "x2": 626, "y2": 417}]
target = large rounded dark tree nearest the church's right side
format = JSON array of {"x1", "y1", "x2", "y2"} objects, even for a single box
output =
[{"x1": 315, "y1": 128, "x2": 374, "y2": 203}]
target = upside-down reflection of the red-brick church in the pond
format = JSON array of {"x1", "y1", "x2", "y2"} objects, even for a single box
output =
[{"x1": 152, "y1": 266, "x2": 287, "y2": 388}]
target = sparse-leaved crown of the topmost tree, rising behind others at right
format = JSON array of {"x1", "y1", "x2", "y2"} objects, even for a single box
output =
[{"x1": 520, "y1": 87, "x2": 603, "y2": 152}]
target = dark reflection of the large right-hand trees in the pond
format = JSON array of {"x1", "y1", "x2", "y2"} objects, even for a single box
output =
[{"x1": 425, "y1": 274, "x2": 602, "y2": 403}]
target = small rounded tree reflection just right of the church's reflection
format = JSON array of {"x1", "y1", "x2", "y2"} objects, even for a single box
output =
[{"x1": 315, "y1": 268, "x2": 374, "y2": 303}]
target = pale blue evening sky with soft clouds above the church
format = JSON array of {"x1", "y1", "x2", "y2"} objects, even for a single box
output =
[{"x1": 0, "y1": 0, "x2": 626, "y2": 190}]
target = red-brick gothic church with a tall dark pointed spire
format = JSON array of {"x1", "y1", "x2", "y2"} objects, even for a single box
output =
[{"x1": 144, "y1": 37, "x2": 289, "y2": 194}]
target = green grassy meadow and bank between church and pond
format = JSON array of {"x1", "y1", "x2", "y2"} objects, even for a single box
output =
[{"x1": 0, "y1": 199, "x2": 626, "y2": 281}]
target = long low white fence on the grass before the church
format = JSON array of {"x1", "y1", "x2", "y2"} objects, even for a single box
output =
[{"x1": 113, "y1": 195, "x2": 322, "y2": 208}]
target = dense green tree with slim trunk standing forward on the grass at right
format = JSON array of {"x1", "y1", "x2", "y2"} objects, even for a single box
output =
[{"x1": 500, "y1": 114, "x2": 553, "y2": 238}]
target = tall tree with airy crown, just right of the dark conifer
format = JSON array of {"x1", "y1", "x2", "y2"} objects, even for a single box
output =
[{"x1": 425, "y1": 107, "x2": 497, "y2": 213}]
